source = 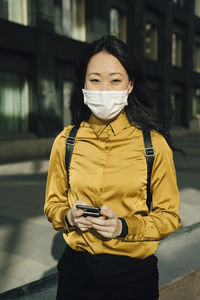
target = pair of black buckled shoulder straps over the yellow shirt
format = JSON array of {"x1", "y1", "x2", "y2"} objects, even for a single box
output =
[{"x1": 65, "y1": 126, "x2": 155, "y2": 211}]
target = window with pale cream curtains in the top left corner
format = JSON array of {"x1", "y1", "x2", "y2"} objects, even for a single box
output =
[{"x1": 0, "y1": 0, "x2": 28, "y2": 25}]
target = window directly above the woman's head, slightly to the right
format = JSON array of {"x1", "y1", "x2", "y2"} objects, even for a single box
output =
[{"x1": 110, "y1": 8, "x2": 127, "y2": 42}]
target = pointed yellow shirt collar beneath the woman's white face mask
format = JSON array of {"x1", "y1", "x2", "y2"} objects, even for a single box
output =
[{"x1": 89, "y1": 113, "x2": 131, "y2": 136}]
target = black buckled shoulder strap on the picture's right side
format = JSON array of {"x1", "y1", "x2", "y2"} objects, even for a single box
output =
[{"x1": 143, "y1": 130, "x2": 155, "y2": 211}]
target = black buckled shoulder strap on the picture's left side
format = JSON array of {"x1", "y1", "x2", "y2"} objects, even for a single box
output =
[{"x1": 65, "y1": 126, "x2": 79, "y2": 186}]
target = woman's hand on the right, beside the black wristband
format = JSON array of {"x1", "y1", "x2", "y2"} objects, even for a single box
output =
[{"x1": 86, "y1": 205, "x2": 122, "y2": 239}]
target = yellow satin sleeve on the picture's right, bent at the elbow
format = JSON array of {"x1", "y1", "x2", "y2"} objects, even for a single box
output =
[{"x1": 125, "y1": 133, "x2": 180, "y2": 241}]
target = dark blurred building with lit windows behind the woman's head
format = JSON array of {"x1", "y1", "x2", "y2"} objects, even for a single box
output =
[{"x1": 0, "y1": 0, "x2": 200, "y2": 162}]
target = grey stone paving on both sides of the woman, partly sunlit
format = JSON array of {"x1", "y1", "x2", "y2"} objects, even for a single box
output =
[{"x1": 0, "y1": 136, "x2": 200, "y2": 300}]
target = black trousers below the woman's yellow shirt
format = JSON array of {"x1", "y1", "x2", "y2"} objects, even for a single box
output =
[{"x1": 56, "y1": 246, "x2": 159, "y2": 300}]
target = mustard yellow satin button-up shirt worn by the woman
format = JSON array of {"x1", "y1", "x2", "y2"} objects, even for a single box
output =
[{"x1": 45, "y1": 114, "x2": 180, "y2": 259}]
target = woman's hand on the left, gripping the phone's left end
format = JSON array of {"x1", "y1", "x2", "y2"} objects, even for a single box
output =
[{"x1": 67, "y1": 200, "x2": 92, "y2": 232}]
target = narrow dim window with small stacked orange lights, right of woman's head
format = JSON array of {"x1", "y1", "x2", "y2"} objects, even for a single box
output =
[{"x1": 145, "y1": 22, "x2": 158, "y2": 60}]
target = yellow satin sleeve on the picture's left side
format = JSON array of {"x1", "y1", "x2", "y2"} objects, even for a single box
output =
[{"x1": 44, "y1": 127, "x2": 70, "y2": 232}]
